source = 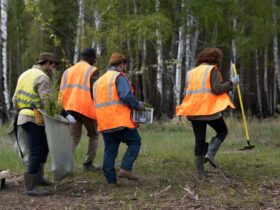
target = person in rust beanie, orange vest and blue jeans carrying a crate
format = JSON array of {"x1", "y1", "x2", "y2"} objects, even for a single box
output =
[{"x1": 93, "y1": 53, "x2": 145, "y2": 184}]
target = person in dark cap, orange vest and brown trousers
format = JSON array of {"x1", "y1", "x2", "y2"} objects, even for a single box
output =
[{"x1": 60, "y1": 48, "x2": 100, "y2": 171}]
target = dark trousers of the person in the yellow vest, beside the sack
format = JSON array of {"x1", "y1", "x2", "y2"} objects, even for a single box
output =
[{"x1": 22, "y1": 122, "x2": 49, "y2": 174}]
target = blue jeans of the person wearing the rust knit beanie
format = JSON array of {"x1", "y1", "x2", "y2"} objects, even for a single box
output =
[{"x1": 102, "y1": 128, "x2": 141, "y2": 183}]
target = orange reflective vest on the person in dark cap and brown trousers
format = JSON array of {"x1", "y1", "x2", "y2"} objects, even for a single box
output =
[{"x1": 59, "y1": 61, "x2": 97, "y2": 119}]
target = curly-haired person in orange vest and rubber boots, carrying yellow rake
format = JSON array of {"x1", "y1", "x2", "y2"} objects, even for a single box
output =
[{"x1": 176, "y1": 48, "x2": 239, "y2": 177}]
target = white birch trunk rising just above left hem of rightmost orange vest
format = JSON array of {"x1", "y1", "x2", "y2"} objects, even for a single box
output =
[{"x1": 174, "y1": 26, "x2": 184, "y2": 106}]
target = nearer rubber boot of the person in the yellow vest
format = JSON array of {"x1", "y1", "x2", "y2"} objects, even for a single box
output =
[{"x1": 24, "y1": 173, "x2": 50, "y2": 196}]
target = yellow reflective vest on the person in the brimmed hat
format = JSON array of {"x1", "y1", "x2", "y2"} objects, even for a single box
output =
[{"x1": 16, "y1": 68, "x2": 46, "y2": 116}]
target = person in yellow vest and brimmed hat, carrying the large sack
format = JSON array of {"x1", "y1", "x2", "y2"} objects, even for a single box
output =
[{"x1": 13, "y1": 52, "x2": 58, "y2": 195}]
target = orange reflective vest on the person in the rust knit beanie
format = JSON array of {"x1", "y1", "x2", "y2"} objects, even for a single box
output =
[{"x1": 93, "y1": 70, "x2": 137, "y2": 131}]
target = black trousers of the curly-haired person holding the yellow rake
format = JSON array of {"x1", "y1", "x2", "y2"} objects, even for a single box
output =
[{"x1": 191, "y1": 117, "x2": 228, "y2": 156}]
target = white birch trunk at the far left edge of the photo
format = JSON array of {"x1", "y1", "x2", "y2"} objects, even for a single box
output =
[{"x1": 1, "y1": 0, "x2": 10, "y2": 110}]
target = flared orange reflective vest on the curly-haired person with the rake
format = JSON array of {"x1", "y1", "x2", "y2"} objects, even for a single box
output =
[{"x1": 176, "y1": 64, "x2": 235, "y2": 116}]
